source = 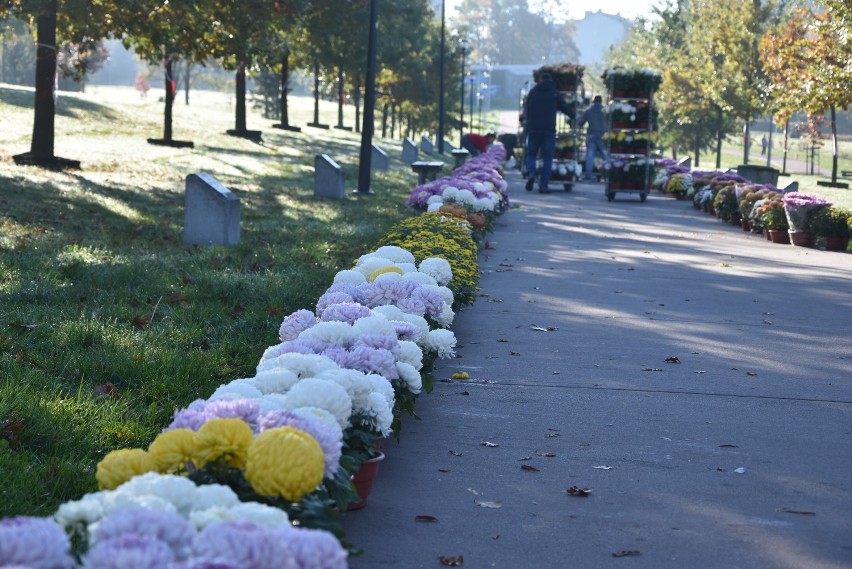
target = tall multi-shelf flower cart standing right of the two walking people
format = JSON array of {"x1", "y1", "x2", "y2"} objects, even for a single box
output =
[{"x1": 602, "y1": 67, "x2": 662, "y2": 202}]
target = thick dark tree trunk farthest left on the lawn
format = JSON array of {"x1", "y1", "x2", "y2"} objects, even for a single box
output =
[{"x1": 30, "y1": 0, "x2": 57, "y2": 160}]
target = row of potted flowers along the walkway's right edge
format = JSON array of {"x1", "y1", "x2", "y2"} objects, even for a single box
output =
[{"x1": 654, "y1": 159, "x2": 852, "y2": 251}]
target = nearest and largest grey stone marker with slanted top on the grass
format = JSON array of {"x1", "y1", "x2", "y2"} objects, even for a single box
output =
[{"x1": 183, "y1": 172, "x2": 240, "y2": 245}]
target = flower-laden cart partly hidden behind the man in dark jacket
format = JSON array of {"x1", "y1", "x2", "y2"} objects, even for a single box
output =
[{"x1": 520, "y1": 63, "x2": 585, "y2": 192}]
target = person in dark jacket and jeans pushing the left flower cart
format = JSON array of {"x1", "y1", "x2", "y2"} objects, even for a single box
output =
[{"x1": 523, "y1": 73, "x2": 574, "y2": 194}]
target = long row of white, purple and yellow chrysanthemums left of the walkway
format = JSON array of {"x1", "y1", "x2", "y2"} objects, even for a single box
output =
[{"x1": 0, "y1": 145, "x2": 509, "y2": 569}]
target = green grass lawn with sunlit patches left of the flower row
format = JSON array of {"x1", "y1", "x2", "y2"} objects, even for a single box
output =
[{"x1": 0, "y1": 85, "x2": 436, "y2": 517}]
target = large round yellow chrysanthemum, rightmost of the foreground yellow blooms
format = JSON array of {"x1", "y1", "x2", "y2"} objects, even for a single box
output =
[{"x1": 245, "y1": 427, "x2": 325, "y2": 502}]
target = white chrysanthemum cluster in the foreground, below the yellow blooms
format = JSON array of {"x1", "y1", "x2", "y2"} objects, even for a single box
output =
[{"x1": 53, "y1": 472, "x2": 290, "y2": 535}]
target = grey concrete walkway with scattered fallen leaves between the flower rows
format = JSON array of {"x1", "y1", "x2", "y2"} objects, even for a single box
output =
[{"x1": 346, "y1": 172, "x2": 852, "y2": 569}]
